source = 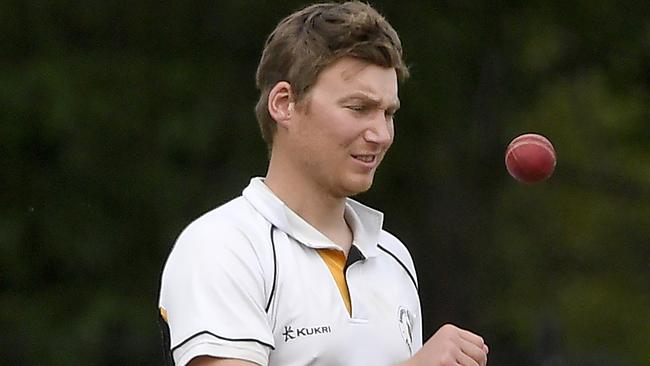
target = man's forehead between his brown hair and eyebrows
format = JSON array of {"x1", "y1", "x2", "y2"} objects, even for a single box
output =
[{"x1": 312, "y1": 58, "x2": 398, "y2": 103}]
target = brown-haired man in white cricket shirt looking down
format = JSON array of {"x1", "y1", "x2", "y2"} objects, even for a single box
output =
[{"x1": 160, "y1": 2, "x2": 487, "y2": 366}]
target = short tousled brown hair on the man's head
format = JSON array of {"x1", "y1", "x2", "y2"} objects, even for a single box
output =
[{"x1": 255, "y1": 1, "x2": 409, "y2": 153}]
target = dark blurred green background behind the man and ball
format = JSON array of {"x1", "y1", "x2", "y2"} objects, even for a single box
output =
[{"x1": 0, "y1": 0, "x2": 650, "y2": 366}]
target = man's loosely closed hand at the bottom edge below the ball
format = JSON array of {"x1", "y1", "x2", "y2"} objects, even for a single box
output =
[{"x1": 403, "y1": 324, "x2": 488, "y2": 366}]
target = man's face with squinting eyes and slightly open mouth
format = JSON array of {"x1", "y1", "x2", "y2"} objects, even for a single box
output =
[{"x1": 290, "y1": 58, "x2": 399, "y2": 197}]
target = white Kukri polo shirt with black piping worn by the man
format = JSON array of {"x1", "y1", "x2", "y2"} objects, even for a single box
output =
[{"x1": 159, "y1": 178, "x2": 422, "y2": 366}]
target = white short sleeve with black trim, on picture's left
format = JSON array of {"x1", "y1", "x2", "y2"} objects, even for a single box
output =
[{"x1": 159, "y1": 221, "x2": 274, "y2": 366}]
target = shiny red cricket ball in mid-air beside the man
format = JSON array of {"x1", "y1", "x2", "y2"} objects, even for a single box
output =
[{"x1": 506, "y1": 133, "x2": 556, "y2": 183}]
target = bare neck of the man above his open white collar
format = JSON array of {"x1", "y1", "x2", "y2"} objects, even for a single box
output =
[{"x1": 264, "y1": 156, "x2": 352, "y2": 253}]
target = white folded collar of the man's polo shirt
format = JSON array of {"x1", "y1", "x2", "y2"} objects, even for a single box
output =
[{"x1": 242, "y1": 177, "x2": 384, "y2": 258}]
